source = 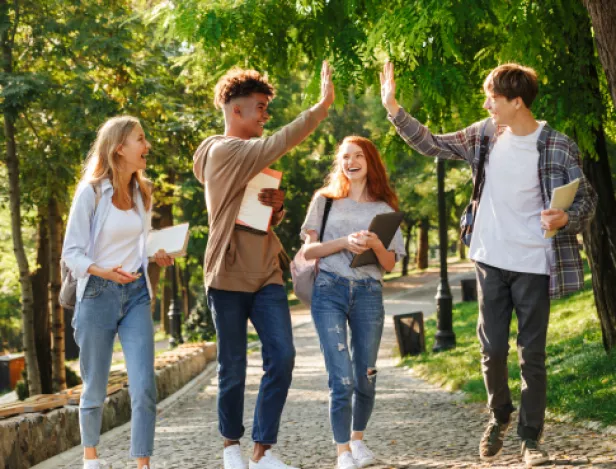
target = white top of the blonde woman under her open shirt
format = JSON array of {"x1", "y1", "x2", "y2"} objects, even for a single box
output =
[{"x1": 93, "y1": 203, "x2": 143, "y2": 272}]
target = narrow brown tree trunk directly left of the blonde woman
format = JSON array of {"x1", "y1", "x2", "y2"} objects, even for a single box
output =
[{"x1": 48, "y1": 196, "x2": 66, "y2": 392}]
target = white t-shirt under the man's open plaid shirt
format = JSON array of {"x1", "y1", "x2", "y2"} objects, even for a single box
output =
[{"x1": 470, "y1": 122, "x2": 552, "y2": 275}]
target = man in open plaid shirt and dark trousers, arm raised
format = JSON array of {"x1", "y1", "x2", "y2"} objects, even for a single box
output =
[{"x1": 381, "y1": 63, "x2": 597, "y2": 466}]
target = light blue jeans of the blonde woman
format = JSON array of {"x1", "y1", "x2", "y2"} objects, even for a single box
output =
[{"x1": 73, "y1": 276, "x2": 156, "y2": 458}]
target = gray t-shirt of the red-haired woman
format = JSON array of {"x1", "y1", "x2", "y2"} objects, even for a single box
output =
[{"x1": 300, "y1": 195, "x2": 405, "y2": 280}]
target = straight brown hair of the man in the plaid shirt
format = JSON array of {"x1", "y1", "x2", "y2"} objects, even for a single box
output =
[{"x1": 483, "y1": 63, "x2": 539, "y2": 109}]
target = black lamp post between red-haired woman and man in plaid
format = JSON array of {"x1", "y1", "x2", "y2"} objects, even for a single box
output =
[{"x1": 432, "y1": 158, "x2": 456, "y2": 352}]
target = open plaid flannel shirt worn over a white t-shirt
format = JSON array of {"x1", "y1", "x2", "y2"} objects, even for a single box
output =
[{"x1": 388, "y1": 108, "x2": 597, "y2": 298}]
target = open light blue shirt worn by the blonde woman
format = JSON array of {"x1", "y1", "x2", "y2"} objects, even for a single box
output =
[{"x1": 62, "y1": 179, "x2": 152, "y2": 301}]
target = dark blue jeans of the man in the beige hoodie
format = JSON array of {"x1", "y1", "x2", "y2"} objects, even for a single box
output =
[{"x1": 207, "y1": 285, "x2": 295, "y2": 445}]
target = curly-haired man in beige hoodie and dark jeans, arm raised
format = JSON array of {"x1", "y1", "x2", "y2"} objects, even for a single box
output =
[{"x1": 193, "y1": 62, "x2": 334, "y2": 469}]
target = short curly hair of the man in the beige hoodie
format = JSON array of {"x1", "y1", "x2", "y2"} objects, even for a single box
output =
[{"x1": 214, "y1": 68, "x2": 275, "y2": 109}]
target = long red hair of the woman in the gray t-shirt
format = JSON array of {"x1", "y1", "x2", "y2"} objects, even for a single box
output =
[{"x1": 317, "y1": 135, "x2": 400, "y2": 211}]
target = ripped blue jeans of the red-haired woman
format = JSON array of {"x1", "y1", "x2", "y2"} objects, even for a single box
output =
[{"x1": 311, "y1": 271, "x2": 385, "y2": 445}]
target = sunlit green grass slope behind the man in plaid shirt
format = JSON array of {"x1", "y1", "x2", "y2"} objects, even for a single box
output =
[{"x1": 401, "y1": 275, "x2": 616, "y2": 425}]
